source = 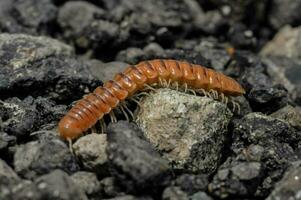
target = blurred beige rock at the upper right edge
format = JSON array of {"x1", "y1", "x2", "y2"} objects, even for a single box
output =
[{"x1": 260, "y1": 25, "x2": 301, "y2": 58}]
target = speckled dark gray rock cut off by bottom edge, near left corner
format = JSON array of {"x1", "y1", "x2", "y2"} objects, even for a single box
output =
[{"x1": 11, "y1": 170, "x2": 88, "y2": 200}]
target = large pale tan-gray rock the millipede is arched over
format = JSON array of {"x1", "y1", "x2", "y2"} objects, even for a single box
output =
[{"x1": 137, "y1": 89, "x2": 232, "y2": 173}]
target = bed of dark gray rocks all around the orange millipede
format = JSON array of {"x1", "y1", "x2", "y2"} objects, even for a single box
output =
[{"x1": 0, "y1": 0, "x2": 301, "y2": 200}]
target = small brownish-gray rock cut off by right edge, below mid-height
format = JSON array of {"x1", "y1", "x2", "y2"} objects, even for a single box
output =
[{"x1": 270, "y1": 105, "x2": 301, "y2": 130}]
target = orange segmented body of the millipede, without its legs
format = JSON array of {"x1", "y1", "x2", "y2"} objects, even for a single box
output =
[{"x1": 58, "y1": 59, "x2": 245, "y2": 140}]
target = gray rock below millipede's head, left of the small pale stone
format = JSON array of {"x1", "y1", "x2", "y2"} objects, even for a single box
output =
[{"x1": 14, "y1": 139, "x2": 78, "y2": 179}]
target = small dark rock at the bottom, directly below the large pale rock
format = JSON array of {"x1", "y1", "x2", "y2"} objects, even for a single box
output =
[{"x1": 174, "y1": 174, "x2": 209, "y2": 195}]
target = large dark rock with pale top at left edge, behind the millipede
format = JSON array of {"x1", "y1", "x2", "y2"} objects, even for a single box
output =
[{"x1": 0, "y1": 34, "x2": 101, "y2": 102}]
